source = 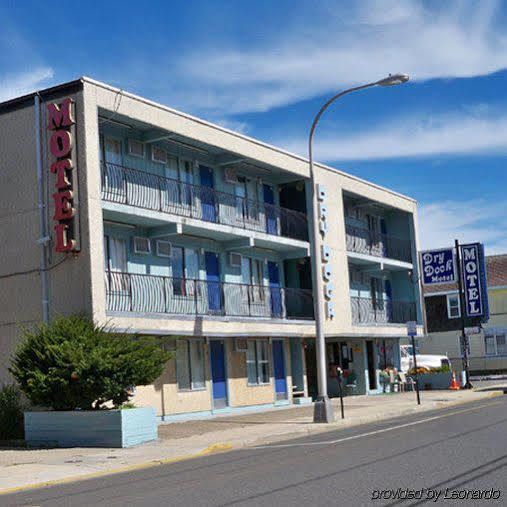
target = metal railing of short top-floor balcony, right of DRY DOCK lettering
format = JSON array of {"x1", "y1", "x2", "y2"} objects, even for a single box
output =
[{"x1": 345, "y1": 225, "x2": 412, "y2": 262}]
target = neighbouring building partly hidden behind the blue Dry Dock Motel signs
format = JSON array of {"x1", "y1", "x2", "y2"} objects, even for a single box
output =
[{"x1": 419, "y1": 254, "x2": 507, "y2": 374}]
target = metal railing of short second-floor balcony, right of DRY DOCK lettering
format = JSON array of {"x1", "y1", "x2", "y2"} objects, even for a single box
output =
[{"x1": 350, "y1": 296, "x2": 417, "y2": 324}]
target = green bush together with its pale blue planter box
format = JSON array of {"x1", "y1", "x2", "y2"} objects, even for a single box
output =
[{"x1": 9, "y1": 315, "x2": 170, "y2": 447}]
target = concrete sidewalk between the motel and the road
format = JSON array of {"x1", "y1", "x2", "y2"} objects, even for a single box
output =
[{"x1": 0, "y1": 391, "x2": 502, "y2": 493}]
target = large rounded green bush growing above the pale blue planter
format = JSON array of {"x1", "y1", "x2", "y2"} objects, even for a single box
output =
[{"x1": 9, "y1": 315, "x2": 170, "y2": 410}]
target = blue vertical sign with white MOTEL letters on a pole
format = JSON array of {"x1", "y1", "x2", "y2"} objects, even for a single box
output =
[{"x1": 460, "y1": 243, "x2": 489, "y2": 321}]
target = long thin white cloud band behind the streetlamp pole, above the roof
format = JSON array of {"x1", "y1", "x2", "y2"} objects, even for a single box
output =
[{"x1": 274, "y1": 107, "x2": 507, "y2": 161}]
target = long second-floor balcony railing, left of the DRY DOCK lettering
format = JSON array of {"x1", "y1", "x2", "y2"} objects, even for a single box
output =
[{"x1": 105, "y1": 271, "x2": 313, "y2": 320}]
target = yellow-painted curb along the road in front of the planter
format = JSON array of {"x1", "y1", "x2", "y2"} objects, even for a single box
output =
[{"x1": 0, "y1": 443, "x2": 232, "y2": 496}]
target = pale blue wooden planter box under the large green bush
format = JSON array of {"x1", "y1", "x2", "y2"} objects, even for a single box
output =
[{"x1": 25, "y1": 407, "x2": 158, "y2": 447}]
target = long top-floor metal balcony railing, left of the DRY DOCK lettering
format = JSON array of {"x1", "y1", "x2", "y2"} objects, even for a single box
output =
[{"x1": 101, "y1": 162, "x2": 308, "y2": 241}]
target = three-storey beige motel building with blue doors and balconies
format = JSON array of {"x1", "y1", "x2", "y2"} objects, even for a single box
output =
[{"x1": 0, "y1": 77, "x2": 422, "y2": 421}]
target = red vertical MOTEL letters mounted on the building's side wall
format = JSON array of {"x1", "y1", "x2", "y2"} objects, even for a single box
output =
[{"x1": 47, "y1": 98, "x2": 78, "y2": 253}]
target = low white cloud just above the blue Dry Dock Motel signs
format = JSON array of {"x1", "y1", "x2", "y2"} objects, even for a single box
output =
[{"x1": 419, "y1": 199, "x2": 507, "y2": 255}]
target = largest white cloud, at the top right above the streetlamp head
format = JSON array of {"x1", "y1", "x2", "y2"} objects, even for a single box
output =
[{"x1": 171, "y1": 0, "x2": 507, "y2": 113}]
